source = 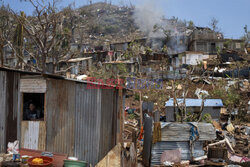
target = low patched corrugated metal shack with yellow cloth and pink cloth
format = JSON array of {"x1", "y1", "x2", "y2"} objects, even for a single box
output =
[{"x1": 142, "y1": 117, "x2": 216, "y2": 167}]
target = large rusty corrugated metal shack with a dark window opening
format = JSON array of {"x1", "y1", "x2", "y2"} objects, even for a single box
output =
[{"x1": 0, "y1": 68, "x2": 123, "y2": 165}]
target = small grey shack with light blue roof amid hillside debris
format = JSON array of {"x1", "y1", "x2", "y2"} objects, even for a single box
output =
[{"x1": 165, "y1": 98, "x2": 224, "y2": 122}]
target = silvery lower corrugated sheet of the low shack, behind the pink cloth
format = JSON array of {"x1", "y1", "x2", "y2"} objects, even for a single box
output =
[{"x1": 151, "y1": 141, "x2": 204, "y2": 165}]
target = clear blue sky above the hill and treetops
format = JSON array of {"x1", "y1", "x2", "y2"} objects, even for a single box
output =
[{"x1": 2, "y1": 0, "x2": 250, "y2": 38}]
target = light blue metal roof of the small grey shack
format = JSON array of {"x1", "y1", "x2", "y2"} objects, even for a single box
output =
[{"x1": 165, "y1": 98, "x2": 223, "y2": 107}]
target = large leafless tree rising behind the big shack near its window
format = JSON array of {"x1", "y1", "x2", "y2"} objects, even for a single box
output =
[{"x1": 5, "y1": 0, "x2": 78, "y2": 73}]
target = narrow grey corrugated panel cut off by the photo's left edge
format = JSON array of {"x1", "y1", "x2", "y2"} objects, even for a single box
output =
[{"x1": 0, "y1": 71, "x2": 6, "y2": 152}]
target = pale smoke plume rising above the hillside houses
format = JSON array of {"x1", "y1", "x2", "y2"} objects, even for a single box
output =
[{"x1": 133, "y1": 0, "x2": 186, "y2": 53}]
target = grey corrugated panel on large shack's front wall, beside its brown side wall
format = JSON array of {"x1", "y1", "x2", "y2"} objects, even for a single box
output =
[{"x1": 75, "y1": 83, "x2": 101, "y2": 165}]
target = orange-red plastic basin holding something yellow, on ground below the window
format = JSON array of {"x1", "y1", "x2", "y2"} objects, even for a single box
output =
[{"x1": 28, "y1": 156, "x2": 53, "y2": 167}]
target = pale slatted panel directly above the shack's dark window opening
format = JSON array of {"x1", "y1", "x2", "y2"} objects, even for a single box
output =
[{"x1": 20, "y1": 78, "x2": 47, "y2": 93}]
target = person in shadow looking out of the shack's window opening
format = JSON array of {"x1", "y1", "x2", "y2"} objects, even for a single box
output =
[{"x1": 24, "y1": 103, "x2": 42, "y2": 120}]
